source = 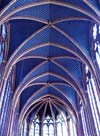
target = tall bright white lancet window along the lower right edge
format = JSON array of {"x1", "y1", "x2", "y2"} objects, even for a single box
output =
[{"x1": 85, "y1": 66, "x2": 100, "y2": 136}]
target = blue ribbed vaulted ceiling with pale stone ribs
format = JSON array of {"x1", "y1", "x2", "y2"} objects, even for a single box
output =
[{"x1": 0, "y1": 0, "x2": 100, "y2": 123}]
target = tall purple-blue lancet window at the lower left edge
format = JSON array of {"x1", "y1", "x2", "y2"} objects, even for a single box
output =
[{"x1": 0, "y1": 70, "x2": 14, "y2": 134}]
